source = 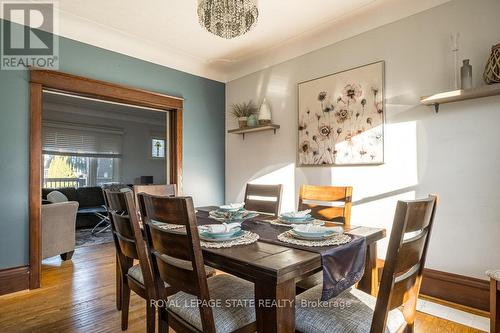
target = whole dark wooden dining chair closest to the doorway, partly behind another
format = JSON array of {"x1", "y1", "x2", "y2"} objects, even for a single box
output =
[{"x1": 104, "y1": 190, "x2": 156, "y2": 333}]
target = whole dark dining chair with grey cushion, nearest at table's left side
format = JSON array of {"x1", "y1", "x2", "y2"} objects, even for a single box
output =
[{"x1": 143, "y1": 195, "x2": 256, "y2": 333}]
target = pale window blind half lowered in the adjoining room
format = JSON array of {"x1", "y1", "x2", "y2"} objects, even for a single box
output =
[{"x1": 42, "y1": 121, "x2": 123, "y2": 157}]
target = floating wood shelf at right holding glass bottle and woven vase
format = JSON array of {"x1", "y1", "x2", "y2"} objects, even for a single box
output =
[{"x1": 420, "y1": 84, "x2": 500, "y2": 113}]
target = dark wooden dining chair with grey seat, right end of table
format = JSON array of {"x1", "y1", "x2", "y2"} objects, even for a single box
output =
[{"x1": 295, "y1": 195, "x2": 437, "y2": 333}]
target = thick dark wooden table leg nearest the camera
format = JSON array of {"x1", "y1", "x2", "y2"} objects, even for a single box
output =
[{"x1": 255, "y1": 279, "x2": 295, "y2": 333}]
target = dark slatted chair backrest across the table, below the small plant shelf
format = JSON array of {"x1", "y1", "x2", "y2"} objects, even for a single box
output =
[{"x1": 245, "y1": 184, "x2": 283, "y2": 216}]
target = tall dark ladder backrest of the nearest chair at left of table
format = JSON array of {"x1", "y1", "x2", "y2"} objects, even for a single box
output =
[{"x1": 142, "y1": 194, "x2": 215, "y2": 333}]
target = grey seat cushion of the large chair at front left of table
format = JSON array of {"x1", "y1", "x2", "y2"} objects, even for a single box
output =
[{"x1": 167, "y1": 274, "x2": 255, "y2": 333}]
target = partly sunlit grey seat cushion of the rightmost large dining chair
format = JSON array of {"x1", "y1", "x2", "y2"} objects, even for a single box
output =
[{"x1": 295, "y1": 285, "x2": 405, "y2": 333}]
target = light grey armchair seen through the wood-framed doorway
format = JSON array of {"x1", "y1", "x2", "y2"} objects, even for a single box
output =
[{"x1": 42, "y1": 201, "x2": 78, "y2": 260}]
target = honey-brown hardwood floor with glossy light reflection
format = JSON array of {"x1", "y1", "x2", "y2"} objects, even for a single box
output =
[{"x1": 0, "y1": 244, "x2": 480, "y2": 333}]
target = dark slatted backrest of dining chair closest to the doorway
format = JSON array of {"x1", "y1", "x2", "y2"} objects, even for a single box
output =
[{"x1": 104, "y1": 190, "x2": 154, "y2": 291}]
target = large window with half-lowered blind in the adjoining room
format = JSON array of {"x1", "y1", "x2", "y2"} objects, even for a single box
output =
[{"x1": 42, "y1": 122, "x2": 122, "y2": 188}]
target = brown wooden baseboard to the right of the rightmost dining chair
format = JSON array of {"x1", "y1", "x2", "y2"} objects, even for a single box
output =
[{"x1": 420, "y1": 268, "x2": 490, "y2": 311}]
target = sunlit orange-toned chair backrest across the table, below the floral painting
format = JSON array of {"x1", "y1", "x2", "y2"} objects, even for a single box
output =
[{"x1": 299, "y1": 185, "x2": 352, "y2": 225}]
